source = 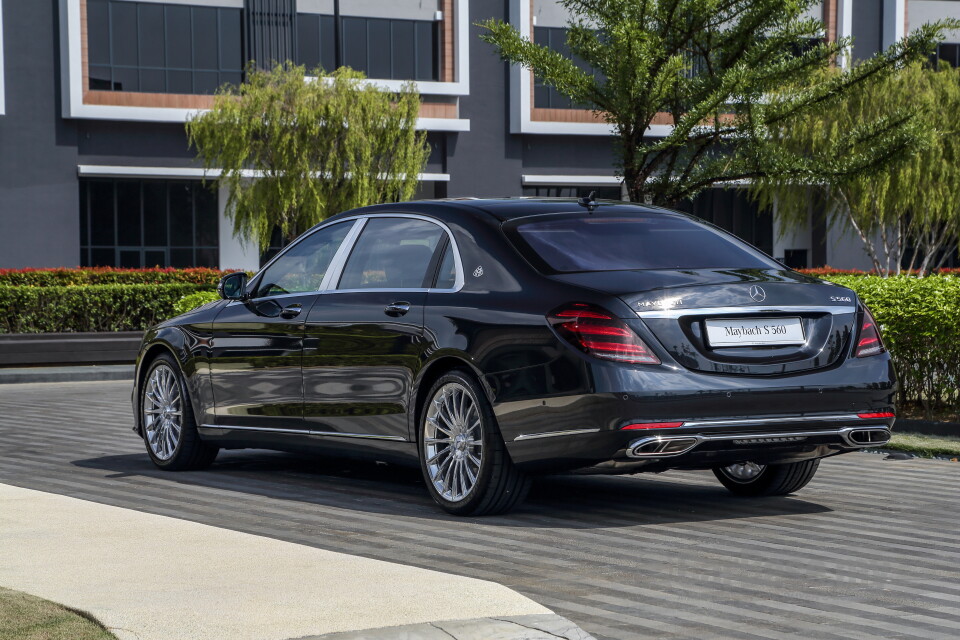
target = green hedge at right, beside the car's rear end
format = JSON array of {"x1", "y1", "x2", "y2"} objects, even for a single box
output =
[{"x1": 824, "y1": 275, "x2": 960, "y2": 409}]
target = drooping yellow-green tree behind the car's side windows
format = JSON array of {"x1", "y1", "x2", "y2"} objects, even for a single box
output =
[{"x1": 187, "y1": 63, "x2": 429, "y2": 250}]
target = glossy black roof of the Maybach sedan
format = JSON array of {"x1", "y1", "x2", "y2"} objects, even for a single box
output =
[{"x1": 324, "y1": 197, "x2": 678, "y2": 222}]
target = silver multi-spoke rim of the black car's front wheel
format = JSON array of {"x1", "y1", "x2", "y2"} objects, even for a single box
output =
[{"x1": 143, "y1": 363, "x2": 183, "y2": 460}]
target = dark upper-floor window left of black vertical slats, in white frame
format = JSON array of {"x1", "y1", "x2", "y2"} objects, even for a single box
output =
[{"x1": 87, "y1": 0, "x2": 243, "y2": 94}]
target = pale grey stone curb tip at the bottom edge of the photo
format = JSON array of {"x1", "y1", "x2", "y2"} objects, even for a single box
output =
[{"x1": 288, "y1": 614, "x2": 595, "y2": 640}]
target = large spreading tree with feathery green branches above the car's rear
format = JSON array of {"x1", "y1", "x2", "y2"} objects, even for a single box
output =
[{"x1": 482, "y1": 0, "x2": 960, "y2": 206}]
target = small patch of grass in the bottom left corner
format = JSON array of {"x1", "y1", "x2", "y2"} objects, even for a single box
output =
[{"x1": 0, "y1": 587, "x2": 116, "y2": 640}]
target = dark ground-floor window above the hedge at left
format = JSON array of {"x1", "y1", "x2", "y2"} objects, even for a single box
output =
[{"x1": 80, "y1": 179, "x2": 220, "y2": 268}]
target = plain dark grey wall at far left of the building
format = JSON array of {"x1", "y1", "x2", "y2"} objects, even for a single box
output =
[{"x1": 0, "y1": 0, "x2": 80, "y2": 267}]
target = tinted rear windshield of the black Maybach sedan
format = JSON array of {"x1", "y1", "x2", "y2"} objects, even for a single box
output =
[{"x1": 505, "y1": 212, "x2": 782, "y2": 273}]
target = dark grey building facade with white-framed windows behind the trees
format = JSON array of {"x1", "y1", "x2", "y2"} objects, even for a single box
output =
[{"x1": 0, "y1": 0, "x2": 960, "y2": 269}]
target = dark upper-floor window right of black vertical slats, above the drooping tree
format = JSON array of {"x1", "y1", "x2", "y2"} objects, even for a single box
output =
[{"x1": 297, "y1": 13, "x2": 440, "y2": 81}]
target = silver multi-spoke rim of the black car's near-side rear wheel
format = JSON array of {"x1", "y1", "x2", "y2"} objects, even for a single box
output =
[{"x1": 423, "y1": 382, "x2": 483, "y2": 502}]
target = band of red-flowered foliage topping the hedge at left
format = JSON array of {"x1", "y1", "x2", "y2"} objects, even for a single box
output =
[{"x1": 0, "y1": 267, "x2": 229, "y2": 287}]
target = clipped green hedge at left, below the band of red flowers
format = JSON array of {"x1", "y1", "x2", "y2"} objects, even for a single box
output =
[{"x1": 0, "y1": 283, "x2": 209, "y2": 333}]
